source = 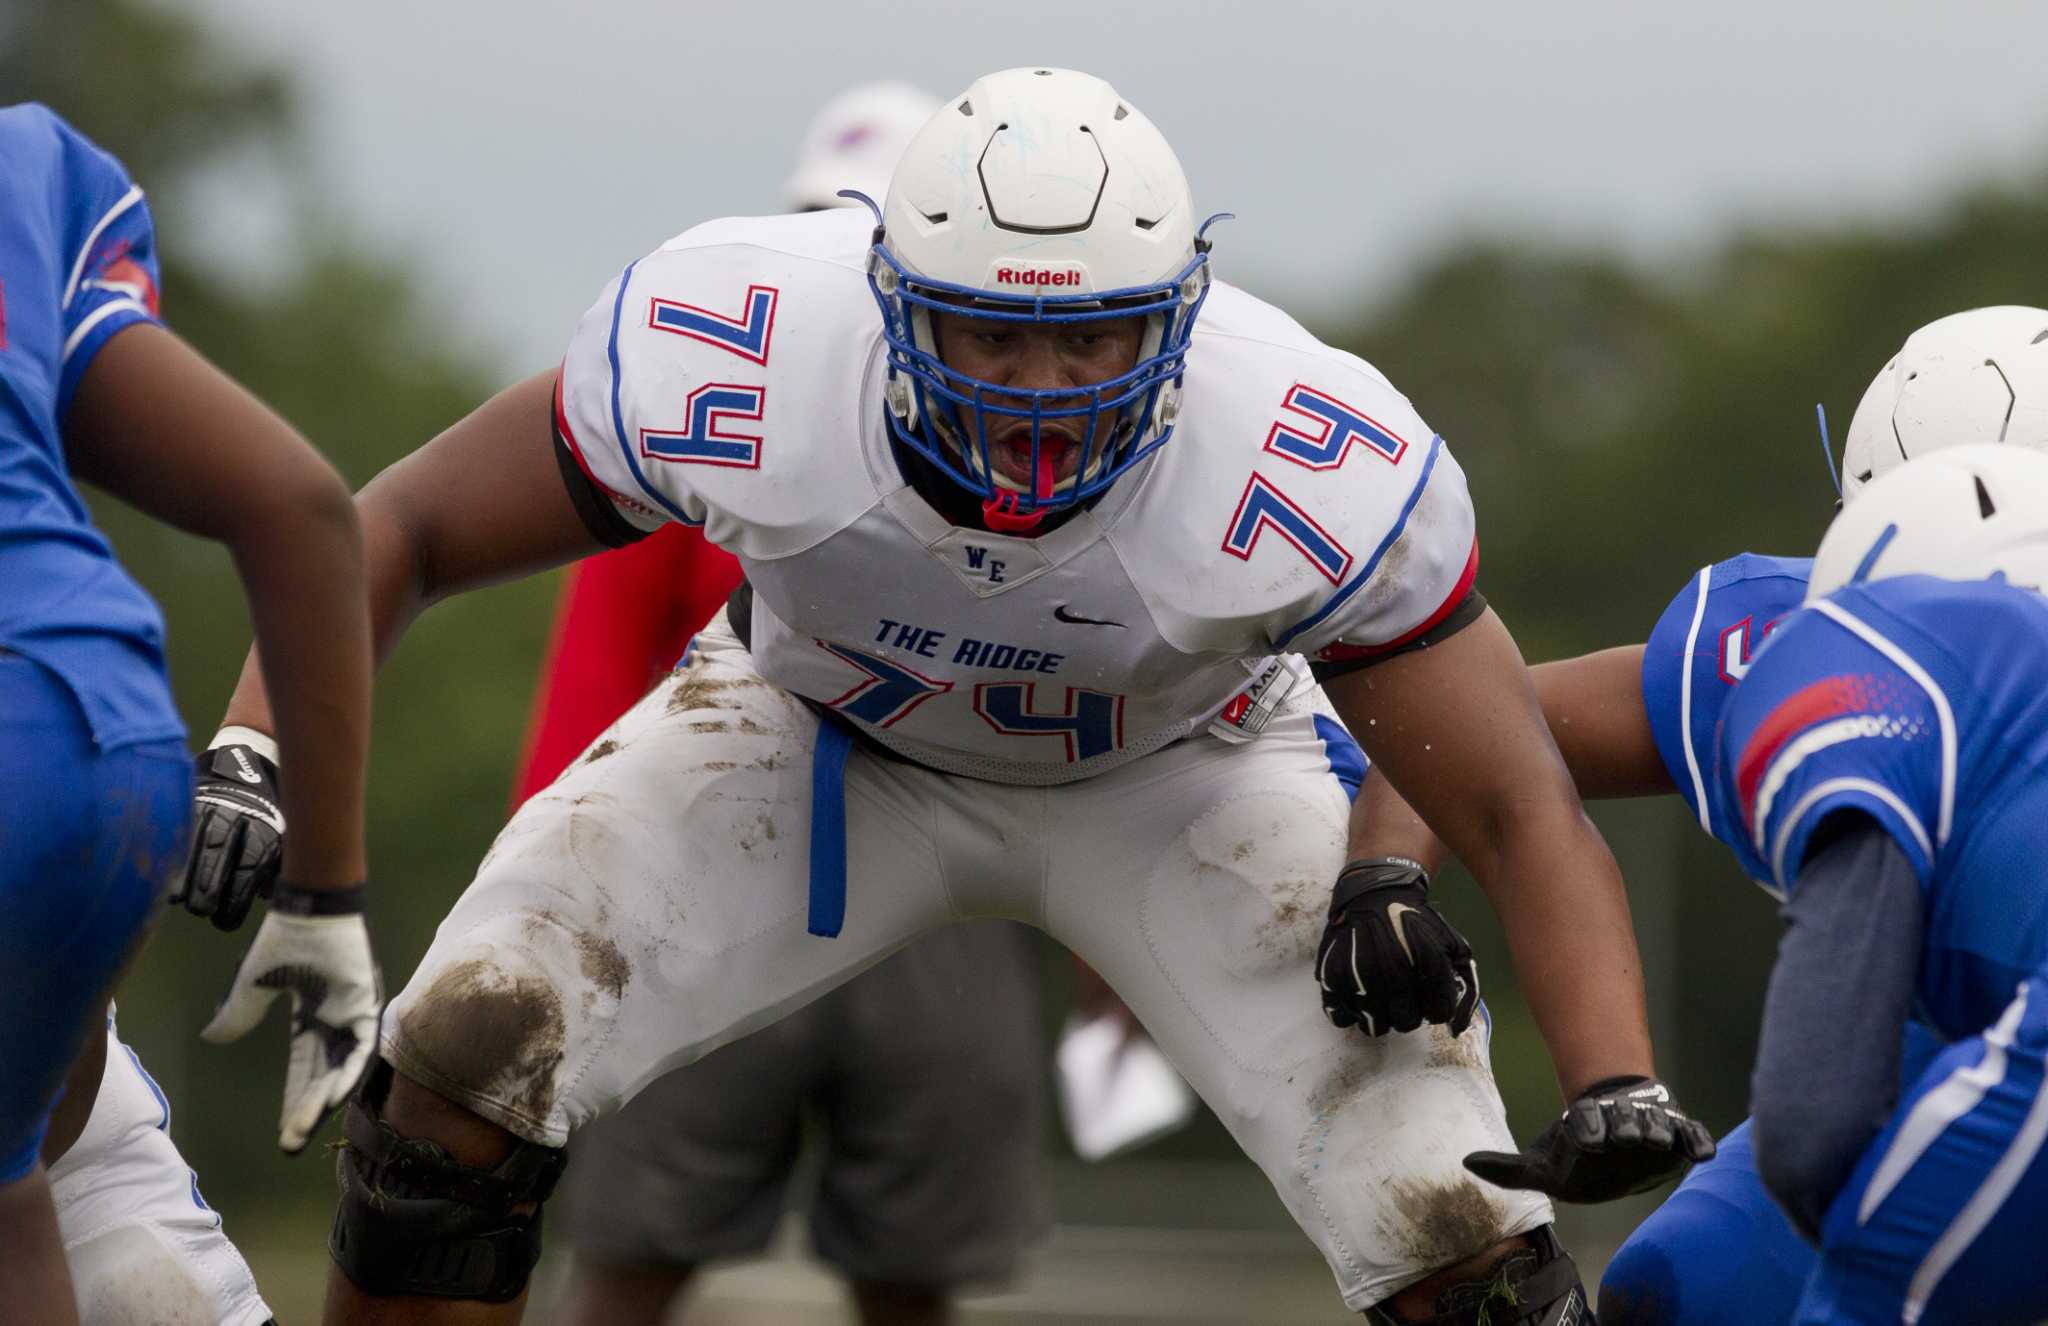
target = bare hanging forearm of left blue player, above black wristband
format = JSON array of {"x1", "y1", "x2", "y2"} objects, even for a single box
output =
[{"x1": 229, "y1": 484, "x2": 371, "y2": 887}]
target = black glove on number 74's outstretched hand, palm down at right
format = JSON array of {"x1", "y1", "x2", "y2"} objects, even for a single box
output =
[{"x1": 1464, "y1": 1078, "x2": 1714, "y2": 1201}]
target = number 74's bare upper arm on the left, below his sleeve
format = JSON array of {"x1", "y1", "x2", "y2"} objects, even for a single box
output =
[{"x1": 356, "y1": 371, "x2": 604, "y2": 603}]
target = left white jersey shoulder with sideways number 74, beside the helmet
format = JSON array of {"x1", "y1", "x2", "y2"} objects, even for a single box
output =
[{"x1": 559, "y1": 209, "x2": 881, "y2": 557}]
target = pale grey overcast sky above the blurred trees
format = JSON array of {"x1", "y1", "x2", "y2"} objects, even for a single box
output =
[{"x1": 162, "y1": 0, "x2": 2048, "y2": 373}]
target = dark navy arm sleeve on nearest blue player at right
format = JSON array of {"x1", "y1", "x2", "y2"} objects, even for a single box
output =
[{"x1": 1751, "y1": 812, "x2": 1923, "y2": 1240}]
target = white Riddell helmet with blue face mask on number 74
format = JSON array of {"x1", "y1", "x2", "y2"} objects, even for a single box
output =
[{"x1": 868, "y1": 70, "x2": 1208, "y2": 529}]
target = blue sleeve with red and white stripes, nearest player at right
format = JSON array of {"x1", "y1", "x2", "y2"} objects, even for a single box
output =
[{"x1": 1716, "y1": 590, "x2": 1956, "y2": 892}]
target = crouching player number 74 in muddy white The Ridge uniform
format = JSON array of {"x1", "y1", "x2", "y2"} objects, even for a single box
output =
[{"x1": 203, "y1": 70, "x2": 1712, "y2": 1324}]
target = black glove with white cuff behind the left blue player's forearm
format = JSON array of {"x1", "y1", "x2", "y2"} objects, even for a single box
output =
[{"x1": 170, "y1": 728, "x2": 285, "y2": 930}]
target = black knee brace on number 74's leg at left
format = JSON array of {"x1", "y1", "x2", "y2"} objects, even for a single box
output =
[{"x1": 328, "y1": 1060, "x2": 567, "y2": 1303}]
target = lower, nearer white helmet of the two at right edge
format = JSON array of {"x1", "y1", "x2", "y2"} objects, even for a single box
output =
[{"x1": 1806, "y1": 443, "x2": 2048, "y2": 600}]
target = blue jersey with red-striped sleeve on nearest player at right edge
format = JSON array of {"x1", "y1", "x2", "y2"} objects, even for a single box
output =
[{"x1": 1718, "y1": 576, "x2": 2048, "y2": 1037}]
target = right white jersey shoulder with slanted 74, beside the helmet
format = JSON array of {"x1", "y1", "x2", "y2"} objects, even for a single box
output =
[{"x1": 1112, "y1": 287, "x2": 1477, "y2": 658}]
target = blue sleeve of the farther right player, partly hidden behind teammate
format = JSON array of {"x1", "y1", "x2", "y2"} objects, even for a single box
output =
[{"x1": 1642, "y1": 553, "x2": 1812, "y2": 844}]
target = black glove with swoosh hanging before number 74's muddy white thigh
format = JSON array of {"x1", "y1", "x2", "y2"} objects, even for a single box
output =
[{"x1": 1315, "y1": 857, "x2": 1479, "y2": 1035}]
